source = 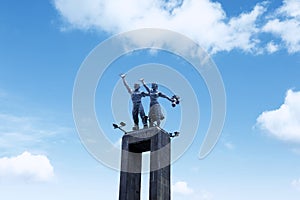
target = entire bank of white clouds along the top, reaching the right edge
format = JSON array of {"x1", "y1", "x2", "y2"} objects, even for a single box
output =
[{"x1": 54, "y1": 0, "x2": 300, "y2": 54}]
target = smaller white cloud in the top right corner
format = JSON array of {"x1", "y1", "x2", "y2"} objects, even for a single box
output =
[{"x1": 262, "y1": 0, "x2": 300, "y2": 53}]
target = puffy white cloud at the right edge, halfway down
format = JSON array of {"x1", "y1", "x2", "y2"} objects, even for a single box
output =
[{"x1": 257, "y1": 90, "x2": 300, "y2": 142}]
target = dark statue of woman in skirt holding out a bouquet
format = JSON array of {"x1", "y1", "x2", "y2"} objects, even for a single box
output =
[{"x1": 140, "y1": 79, "x2": 179, "y2": 127}]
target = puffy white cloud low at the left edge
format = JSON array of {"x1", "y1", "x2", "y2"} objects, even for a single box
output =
[{"x1": 0, "y1": 152, "x2": 54, "y2": 182}]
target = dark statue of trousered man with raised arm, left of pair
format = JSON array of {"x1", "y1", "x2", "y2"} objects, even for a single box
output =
[{"x1": 120, "y1": 74, "x2": 148, "y2": 130}]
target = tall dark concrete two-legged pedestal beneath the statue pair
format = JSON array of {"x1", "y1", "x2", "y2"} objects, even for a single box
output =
[{"x1": 119, "y1": 127, "x2": 171, "y2": 200}]
